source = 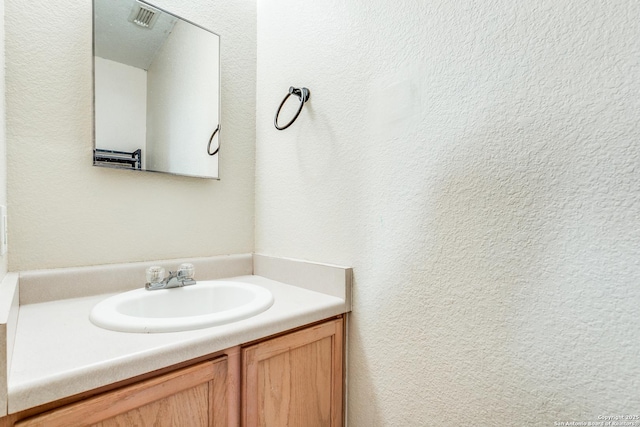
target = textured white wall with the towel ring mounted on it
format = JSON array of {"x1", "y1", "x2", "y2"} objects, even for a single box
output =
[{"x1": 256, "y1": 0, "x2": 640, "y2": 426}]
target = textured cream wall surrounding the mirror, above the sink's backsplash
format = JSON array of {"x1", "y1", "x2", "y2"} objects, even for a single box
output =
[{"x1": 5, "y1": 0, "x2": 256, "y2": 271}]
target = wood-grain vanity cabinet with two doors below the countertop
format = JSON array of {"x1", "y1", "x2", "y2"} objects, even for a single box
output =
[{"x1": 0, "y1": 317, "x2": 344, "y2": 427}]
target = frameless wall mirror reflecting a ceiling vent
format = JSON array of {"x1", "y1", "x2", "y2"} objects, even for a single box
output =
[{"x1": 93, "y1": 0, "x2": 220, "y2": 178}]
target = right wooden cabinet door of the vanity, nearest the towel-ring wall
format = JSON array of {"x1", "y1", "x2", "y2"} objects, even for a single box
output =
[{"x1": 242, "y1": 319, "x2": 343, "y2": 427}]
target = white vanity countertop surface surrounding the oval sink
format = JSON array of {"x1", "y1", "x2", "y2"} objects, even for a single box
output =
[{"x1": 8, "y1": 275, "x2": 350, "y2": 413}]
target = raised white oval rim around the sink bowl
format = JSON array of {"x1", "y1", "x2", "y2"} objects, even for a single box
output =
[{"x1": 89, "y1": 280, "x2": 274, "y2": 333}]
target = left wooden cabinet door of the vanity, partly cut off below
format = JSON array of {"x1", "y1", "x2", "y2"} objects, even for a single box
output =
[{"x1": 16, "y1": 357, "x2": 228, "y2": 427}]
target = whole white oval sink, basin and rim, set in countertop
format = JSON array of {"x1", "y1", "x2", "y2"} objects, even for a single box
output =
[{"x1": 89, "y1": 280, "x2": 273, "y2": 332}]
